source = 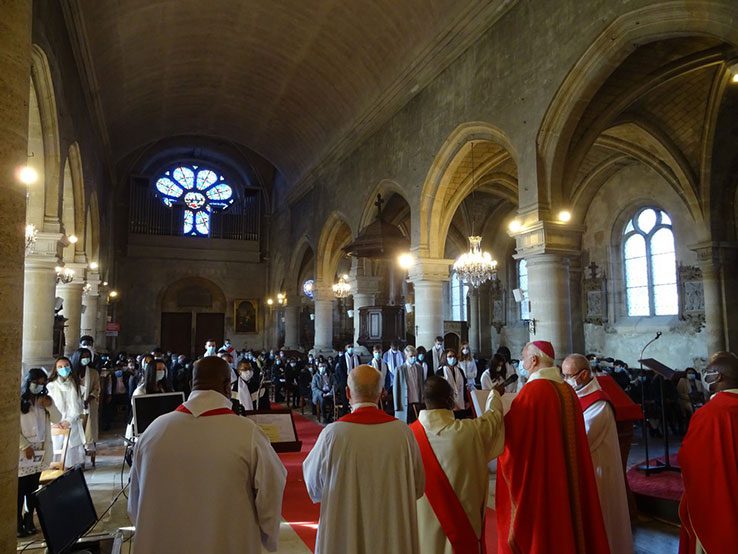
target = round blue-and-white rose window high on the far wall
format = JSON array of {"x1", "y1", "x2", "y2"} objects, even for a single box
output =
[{"x1": 156, "y1": 165, "x2": 233, "y2": 237}]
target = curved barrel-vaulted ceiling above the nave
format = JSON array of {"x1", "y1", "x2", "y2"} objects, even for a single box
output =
[{"x1": 62, "y1": 0, "x2": 515, "y2": 182}]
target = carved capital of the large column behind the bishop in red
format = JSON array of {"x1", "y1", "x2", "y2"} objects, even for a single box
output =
[{"x1": 508, "y1": 220, "x2": 585, "y2": 260}]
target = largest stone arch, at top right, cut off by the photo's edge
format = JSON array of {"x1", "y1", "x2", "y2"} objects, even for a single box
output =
[{"x1": 536, "y1": 1, "x2": 738, "y2": 211}]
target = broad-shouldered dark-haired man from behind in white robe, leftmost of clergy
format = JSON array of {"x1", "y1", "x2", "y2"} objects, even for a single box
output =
[{"x1": 128, "y1": 356, "x2": 287, "y2": 554}]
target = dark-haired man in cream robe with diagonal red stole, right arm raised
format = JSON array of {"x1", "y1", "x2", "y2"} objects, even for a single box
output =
[{"x1": 410, "y1": 376, "x2": 505, "y2": 554}]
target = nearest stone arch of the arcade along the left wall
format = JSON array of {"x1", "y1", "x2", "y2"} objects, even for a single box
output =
[{"x1": 31, "y1": 44, "x2": 61, "y2": 232}]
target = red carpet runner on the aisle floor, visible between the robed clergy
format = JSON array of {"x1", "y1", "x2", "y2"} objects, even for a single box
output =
[{"x1": 279, "y1": 414, "x2": 497, "y2": 554}]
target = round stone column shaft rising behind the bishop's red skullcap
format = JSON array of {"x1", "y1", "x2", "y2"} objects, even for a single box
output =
[{"x1": 526, "y1": 254, "x2": 572, "y2": 361}]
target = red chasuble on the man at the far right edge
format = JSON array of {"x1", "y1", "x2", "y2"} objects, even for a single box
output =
[{"x1": 679, "y1": 392, "x2": 738, "y2": 554}]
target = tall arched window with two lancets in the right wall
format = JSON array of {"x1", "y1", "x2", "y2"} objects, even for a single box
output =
[{"x1": 623, "y1": 208, "x2": 679, "y2": 316}]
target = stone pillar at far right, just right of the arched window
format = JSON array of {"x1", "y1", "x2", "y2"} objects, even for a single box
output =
[{"x1": 692, "y1": 243, "x2": 727, "y2": 358}]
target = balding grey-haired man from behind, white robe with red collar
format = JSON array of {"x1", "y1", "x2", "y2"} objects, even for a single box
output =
[{"x1": 303, "y1": 365, "x2": 425, "y2": 554}]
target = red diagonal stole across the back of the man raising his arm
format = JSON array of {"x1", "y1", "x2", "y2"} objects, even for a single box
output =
[{"x1": 410, "y1": 421, "x2": 485, "y2": 554}]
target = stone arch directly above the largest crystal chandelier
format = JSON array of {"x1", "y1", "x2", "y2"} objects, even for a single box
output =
[{"x1": 413, "y1": 122, "x2": 518, "y2": 257}]
